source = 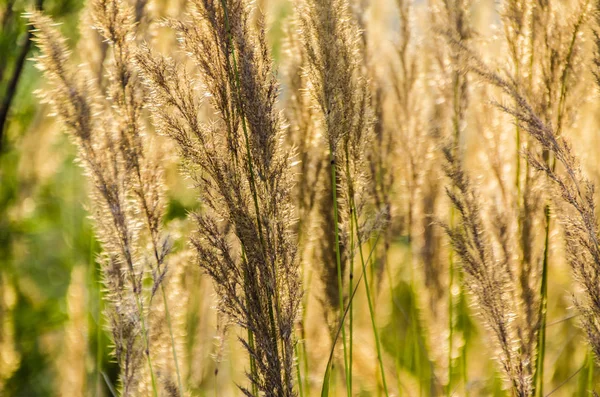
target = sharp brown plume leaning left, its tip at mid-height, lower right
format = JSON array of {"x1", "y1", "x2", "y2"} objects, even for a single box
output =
[{"x1": 444, "y1": 141, "x2": 533, "y2": 396}]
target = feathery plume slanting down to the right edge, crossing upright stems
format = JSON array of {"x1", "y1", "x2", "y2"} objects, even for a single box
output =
[{"x1": 472, "y1": 56, "x2": 600, "y2": 368}]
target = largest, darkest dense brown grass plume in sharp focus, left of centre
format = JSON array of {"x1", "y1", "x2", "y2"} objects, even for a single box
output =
[{"x1": 136, "y1": 0, "x2": 302, "y2": 396}]
